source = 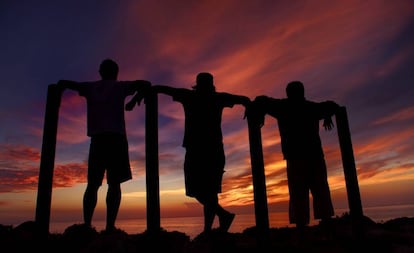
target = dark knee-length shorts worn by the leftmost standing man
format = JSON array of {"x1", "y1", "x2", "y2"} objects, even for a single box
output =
[{"x1": 88, "y1": 134, "x2": 132, "y2": 185}]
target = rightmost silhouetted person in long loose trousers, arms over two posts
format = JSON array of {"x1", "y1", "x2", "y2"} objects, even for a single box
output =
[{"x1": 249, "y1": 81, "x2": 339, "y2": 233}]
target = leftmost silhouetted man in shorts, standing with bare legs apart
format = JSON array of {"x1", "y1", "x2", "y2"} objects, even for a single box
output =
[{"x1": 58, "y1": 59, "x2": 151, "y2": 232}]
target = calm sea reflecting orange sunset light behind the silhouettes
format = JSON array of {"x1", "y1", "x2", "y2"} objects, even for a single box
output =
[{"x1": 50, "y1": 204, "x2": 414, "y2": 238}]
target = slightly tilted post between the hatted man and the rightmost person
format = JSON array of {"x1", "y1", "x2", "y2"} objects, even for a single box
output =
[{"x1": 247, "y1": 116, "x2": 269, "y2": 245}]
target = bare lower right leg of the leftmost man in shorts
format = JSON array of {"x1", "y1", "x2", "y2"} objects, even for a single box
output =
[{"x1": 106, "y1": 184, "x2": 121, "y2": 231}]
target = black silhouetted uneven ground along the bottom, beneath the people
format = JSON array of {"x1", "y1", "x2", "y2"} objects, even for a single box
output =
[{"x1": 0, "y1": 216, "x2": 414, "y2": 253}]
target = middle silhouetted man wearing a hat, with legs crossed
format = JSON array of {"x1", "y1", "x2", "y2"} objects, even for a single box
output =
[{"x1": 127, "y1": 72, "x2": 250, "y2": 233}]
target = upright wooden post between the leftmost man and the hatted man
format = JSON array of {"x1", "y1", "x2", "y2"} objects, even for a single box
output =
[{"x1": 145, "y1": 92, "x2": 161, "y2": 232}]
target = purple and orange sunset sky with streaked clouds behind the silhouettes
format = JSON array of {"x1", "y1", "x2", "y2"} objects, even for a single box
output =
[{"x1": 0, "y1": 0, "x2": 414, "y2": 229}]
